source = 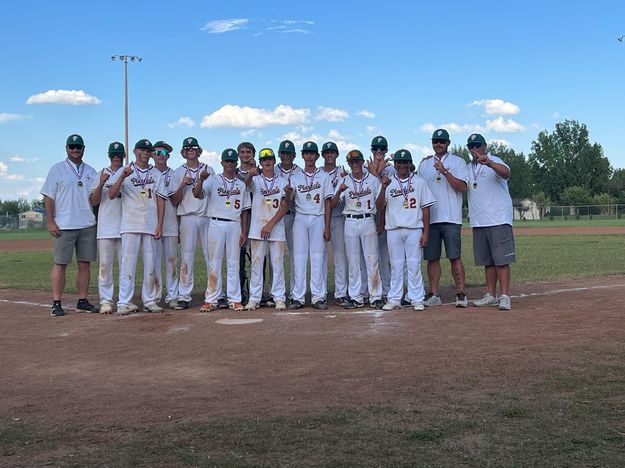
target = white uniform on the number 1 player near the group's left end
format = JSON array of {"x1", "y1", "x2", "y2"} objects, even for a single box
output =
[{"x1": 106, "y1": 163, "x2": 167, "y2": 307}]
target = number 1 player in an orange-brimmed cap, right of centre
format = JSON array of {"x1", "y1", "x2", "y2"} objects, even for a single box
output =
[{"x1": 332, "y1": 150, "x2": 384, "y2": 309}]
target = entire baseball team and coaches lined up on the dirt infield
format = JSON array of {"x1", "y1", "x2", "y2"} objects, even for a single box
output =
[{"x1": 41, "y1": 128, "x2": 516, "y2": 317}]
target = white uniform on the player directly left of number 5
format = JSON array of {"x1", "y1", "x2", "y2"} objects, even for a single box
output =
[{"x1": 169, "y1": 163, "x2": 215, "y2": 302}]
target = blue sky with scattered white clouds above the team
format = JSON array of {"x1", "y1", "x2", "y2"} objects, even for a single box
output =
[{"x1": 0, "y1": 0, "x2": 625, "y2": 199}]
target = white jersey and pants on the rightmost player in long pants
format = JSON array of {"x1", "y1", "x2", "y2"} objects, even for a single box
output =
[{"x1": 385, "y1": 174, "x2": 436, "y2": 304}]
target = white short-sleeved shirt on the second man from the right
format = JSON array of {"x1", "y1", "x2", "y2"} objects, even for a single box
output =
[{"x1": 418, "y1": 153, "x2": 469, "y2": 224}]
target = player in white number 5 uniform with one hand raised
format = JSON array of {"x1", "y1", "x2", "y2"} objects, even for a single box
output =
[{"x1": 193, "y1": 148, "x2": 251, "y2": 312}]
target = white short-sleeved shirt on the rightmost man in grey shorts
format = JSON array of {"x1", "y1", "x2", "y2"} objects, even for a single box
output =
[{"x1": 467, "y1": 153, "x2": 512, "y2": 227}]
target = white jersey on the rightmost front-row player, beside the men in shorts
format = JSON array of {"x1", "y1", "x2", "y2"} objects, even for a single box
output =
[{"x1": 384, "y1": 174, "x2": 436, "y2": 231}]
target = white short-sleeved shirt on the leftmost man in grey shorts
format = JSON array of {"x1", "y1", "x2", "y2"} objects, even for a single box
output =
[{"x1": 40, "y1": 158, "x2": 98, "y2": 229}]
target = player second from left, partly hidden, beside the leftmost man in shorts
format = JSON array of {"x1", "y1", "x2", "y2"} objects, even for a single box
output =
[{"x1": 89, "y1": 141, "x2": 126, "y2": 314}]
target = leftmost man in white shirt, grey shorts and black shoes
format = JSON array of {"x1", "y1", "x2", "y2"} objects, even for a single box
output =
[{"x1": 41, "y1": 134, "x2": 98, "y2": 317}]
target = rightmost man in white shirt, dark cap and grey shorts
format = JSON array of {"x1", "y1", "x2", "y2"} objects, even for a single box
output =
[{"x1": 467, "y1": 133, "x2": 516, "y2": 310}]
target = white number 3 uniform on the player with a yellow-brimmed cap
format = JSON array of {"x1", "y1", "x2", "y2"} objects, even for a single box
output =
[{"x1": 249, "y1": 174, "x2": 288, "y2": 302}]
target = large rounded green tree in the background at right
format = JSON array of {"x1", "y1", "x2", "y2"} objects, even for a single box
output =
[{"x1": 529, "y1": 120, "x2": 612, "y2": 199}]
